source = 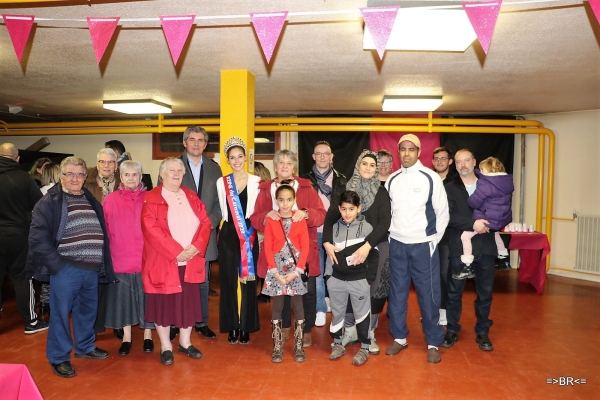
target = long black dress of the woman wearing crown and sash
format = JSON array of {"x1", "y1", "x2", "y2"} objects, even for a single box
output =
[{"x1": 217, "y1": 188, "x2": 260, "y2": 333}]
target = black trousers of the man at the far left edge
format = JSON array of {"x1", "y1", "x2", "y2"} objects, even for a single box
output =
[{"x1": 0, "y1": 230, "x2": 37, "y2": 324}]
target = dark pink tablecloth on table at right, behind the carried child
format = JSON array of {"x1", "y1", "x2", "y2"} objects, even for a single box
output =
[{"x1": 508, "y1": 232, "x2": 550, "y2": 294}]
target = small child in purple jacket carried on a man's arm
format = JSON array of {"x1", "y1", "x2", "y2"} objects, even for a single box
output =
[{"x1": 452, "y1": 157, "x2": 515, "y2": 279}]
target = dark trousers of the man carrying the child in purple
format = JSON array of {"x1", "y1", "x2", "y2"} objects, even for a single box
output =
[{"x1": 446, "y1": 254, "x2": 496, "y2": 335}]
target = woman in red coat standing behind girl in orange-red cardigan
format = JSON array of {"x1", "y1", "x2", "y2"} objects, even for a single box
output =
[{"x1": 250, "y1": 150, "x2": 327, "y2": 347}]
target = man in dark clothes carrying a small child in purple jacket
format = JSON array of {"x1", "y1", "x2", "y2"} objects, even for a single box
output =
[{"x1": 442, "y1": 149, "x2": 498, "y2": 351}]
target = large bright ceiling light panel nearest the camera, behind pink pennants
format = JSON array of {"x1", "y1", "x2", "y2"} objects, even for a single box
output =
[{"x1": 363, "y1": 8, "x2": 477, "y2": 52}]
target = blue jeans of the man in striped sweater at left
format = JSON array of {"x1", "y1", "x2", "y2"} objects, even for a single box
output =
[{"x1": 46, "y1": 265, "x2": 98, "y2": 364}]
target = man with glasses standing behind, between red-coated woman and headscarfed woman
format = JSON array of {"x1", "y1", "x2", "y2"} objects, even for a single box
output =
[{"x1": 302, "y1": 140, "x2": 346, "y2": 326}]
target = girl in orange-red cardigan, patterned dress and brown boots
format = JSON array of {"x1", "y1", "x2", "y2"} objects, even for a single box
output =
[{"x1": 262, "y1": 185, "x2": 309, "y2": 363}]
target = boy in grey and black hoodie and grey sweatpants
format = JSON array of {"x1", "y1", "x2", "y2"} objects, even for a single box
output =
[{"x1": 325, "y1": 190, "x2": 379, "y2": 365}]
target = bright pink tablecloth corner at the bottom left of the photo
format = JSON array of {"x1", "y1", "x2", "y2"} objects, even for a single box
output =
[{"x1": 0, "y1": 364, "x2": 43, "y2": 400}]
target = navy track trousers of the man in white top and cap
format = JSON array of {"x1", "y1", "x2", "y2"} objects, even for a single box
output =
[{"x1": 388, "y1": 239, "x2": 444, "y2": 346}]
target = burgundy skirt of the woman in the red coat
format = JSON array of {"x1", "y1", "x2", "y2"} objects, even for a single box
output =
[{"x1": 145, "y1": 265, "x2": 202, "y2": 329}]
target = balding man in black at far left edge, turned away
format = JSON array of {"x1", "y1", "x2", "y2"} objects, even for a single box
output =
[{"x1": 0, "y1": 143, "x2": 48, "y2": 334}]
